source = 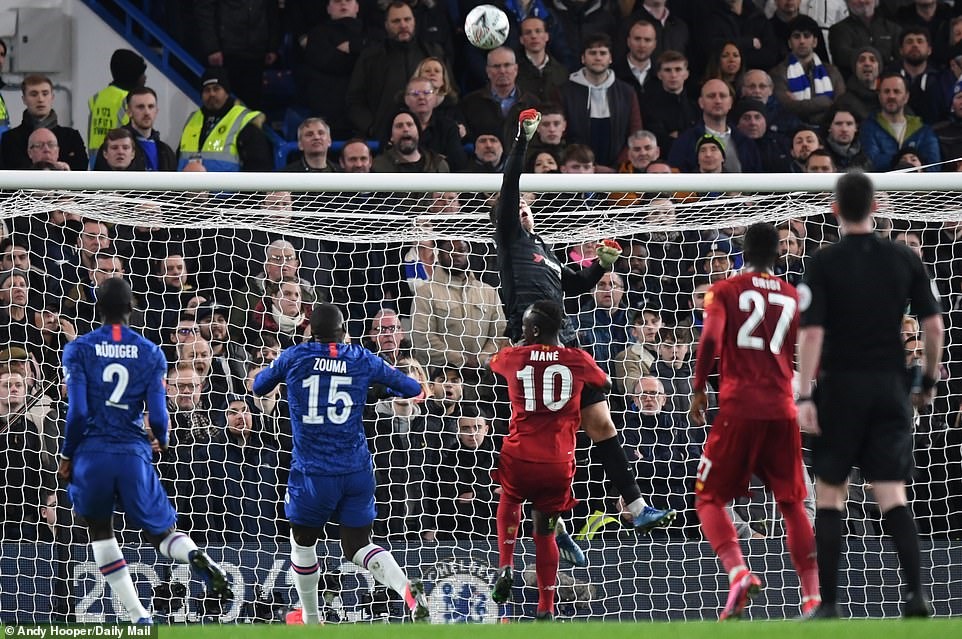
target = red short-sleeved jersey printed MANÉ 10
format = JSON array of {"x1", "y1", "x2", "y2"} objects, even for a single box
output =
[{"x1": 491, "y1": 344, "x2": 607, "y2": 463}]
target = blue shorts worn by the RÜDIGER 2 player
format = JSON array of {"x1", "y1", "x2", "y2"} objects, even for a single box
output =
[{"x1": 67, "y1": 452, "x2": 177, "y2": 535}]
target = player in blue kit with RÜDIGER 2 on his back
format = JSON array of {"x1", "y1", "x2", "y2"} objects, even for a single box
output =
[{"x1": 58, "y1": 278, "x2": 233, "y2": 623}]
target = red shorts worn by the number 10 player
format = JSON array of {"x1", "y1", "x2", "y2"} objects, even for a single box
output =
[{"x1": 491, "y1": 453, "x2": 578, "y2": 515}]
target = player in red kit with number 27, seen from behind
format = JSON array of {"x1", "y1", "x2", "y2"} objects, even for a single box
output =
[{"x1": 689, "y1": 224, "x2": 820, "y2": 619}]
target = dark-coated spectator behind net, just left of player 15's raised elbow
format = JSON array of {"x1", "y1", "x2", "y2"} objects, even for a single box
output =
[{"x1": 205, "y1": 394, "x2": 281, "y2": 544}]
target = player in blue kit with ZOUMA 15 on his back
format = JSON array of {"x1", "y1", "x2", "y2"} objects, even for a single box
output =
[{"x1": 253, "y1": 304, "x2": 429, "y2": 624}]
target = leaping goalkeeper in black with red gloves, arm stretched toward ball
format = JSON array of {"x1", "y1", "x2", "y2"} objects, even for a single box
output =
[{"x1": 493, "y1": 109, "x2": 676, "y2": 566}]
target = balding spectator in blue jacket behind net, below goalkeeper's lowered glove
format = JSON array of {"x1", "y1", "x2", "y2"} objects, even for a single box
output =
[{"x1": 572, "y1": 271, "x2": 630, "y2": 375}]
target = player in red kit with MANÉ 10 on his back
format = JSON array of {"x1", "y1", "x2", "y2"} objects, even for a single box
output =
[{"x1": 490, "y1": 300, "x2": 644, "y2": 619}]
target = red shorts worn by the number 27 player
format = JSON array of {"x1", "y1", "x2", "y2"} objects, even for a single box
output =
[{"x1": 695, "y1": 407, "x2": 808, "y2": 503}]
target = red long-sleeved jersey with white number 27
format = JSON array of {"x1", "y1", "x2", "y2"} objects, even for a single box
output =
[{"x1": 693, "y1": 272, "x2": 799, "y2": 419}]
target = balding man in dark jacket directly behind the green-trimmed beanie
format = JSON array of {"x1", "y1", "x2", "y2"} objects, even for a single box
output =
[{"x1": 668, "y1": 79, "x2": 761, "y2": 173}]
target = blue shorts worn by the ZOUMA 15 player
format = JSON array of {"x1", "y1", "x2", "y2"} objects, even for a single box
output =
[{"x1": 284, "y1": 468, "x2": 376, "y2": 528}]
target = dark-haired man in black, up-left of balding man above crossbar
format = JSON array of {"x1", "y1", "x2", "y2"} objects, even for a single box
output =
[{"x1": 641, "y1": 50, "x2": 700, "y2": 156}]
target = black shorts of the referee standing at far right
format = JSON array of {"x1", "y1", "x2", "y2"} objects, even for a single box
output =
[{"x1": 812, "y1": 371, "x2": 915, "y2": 484}]
